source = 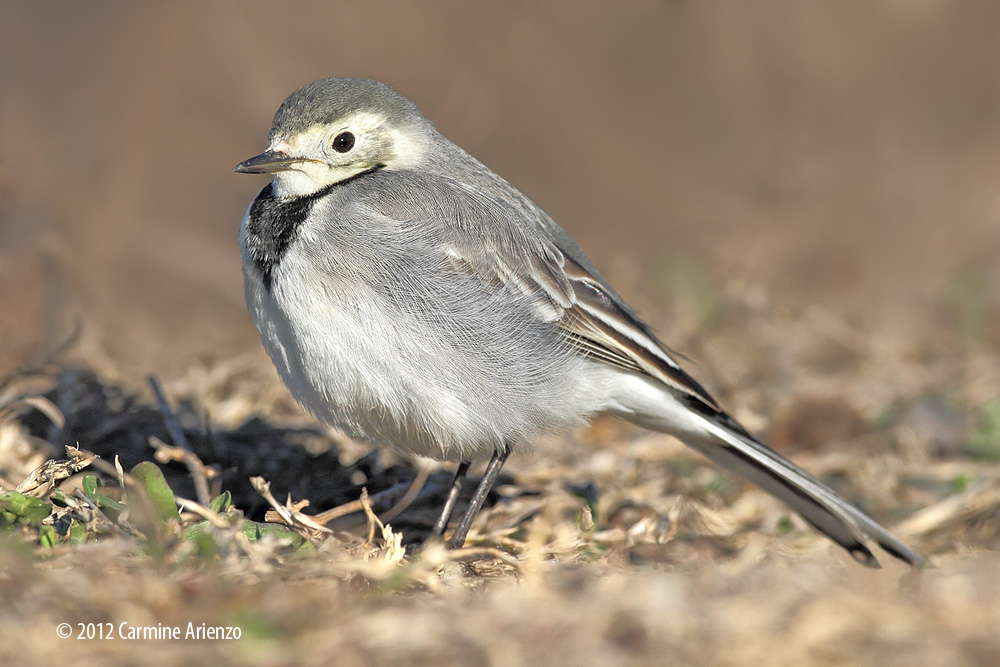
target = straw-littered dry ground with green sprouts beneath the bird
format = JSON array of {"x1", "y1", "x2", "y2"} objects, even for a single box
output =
[{"x1": 0, "y1": 286, "x2": 1000, "y2": 665}]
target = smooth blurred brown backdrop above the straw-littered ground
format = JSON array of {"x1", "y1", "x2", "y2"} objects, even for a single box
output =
[{"x1": 0, "y1": 0, "x2": 1000, "y2": 394}]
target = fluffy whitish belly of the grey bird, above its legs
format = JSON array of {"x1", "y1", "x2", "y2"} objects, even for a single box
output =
[{"x1": 244, "y1": 240, "x2": 605, "y2": 460}]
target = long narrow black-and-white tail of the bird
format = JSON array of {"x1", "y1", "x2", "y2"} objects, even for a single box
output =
[{"x1": 684, "y1": 406, "x2": 927, "y2": 568}]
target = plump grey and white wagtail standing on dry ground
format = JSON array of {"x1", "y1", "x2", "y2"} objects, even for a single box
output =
[{"x1": 234, "y1": 77, "x2": 926, "y2": 567}]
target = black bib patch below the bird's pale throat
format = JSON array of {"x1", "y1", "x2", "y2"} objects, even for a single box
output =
[{"x1": 247, "y1": 183, "x2": 334, "y2": 292}]
